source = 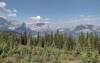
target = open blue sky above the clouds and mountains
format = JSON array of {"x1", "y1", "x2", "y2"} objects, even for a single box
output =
[{"x1": 1, "y1": 0, "x2": 100, "y2": 27}]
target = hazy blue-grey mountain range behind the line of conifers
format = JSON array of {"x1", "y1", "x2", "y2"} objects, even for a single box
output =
[{"x1": 0, "y1": 17, "x2": 100, "y2": 33}]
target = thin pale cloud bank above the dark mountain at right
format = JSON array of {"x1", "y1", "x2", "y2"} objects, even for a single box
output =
[{"x1": 65, "y1": 15, "x2": 100, "y2": 28}]
